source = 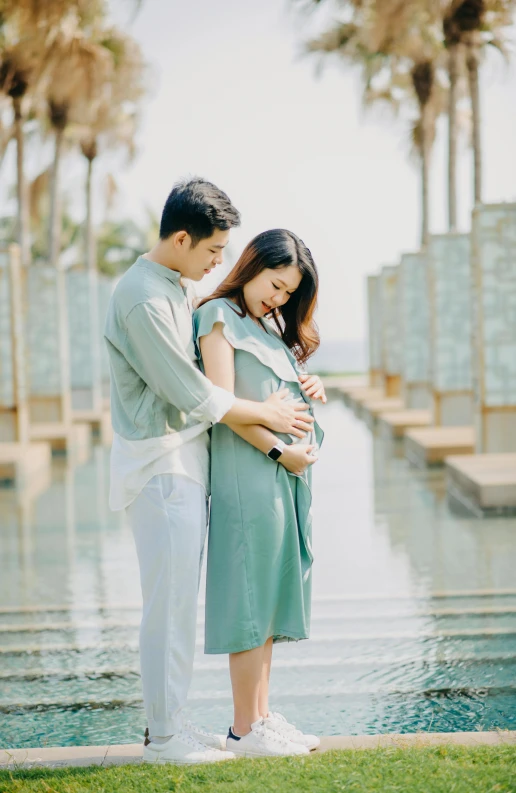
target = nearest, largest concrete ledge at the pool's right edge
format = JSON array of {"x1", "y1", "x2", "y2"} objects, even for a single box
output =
[{"x1": 445, "y1": 454, "x2": 516, "y2": 515}]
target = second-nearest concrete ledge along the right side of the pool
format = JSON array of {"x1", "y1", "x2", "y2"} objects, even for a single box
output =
[{"x1": 405, "y1": 427, "x2": 475, "y2": 468}]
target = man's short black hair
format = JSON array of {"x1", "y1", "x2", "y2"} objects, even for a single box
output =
[{"x1": 159, "y1": 177, "x2": 240, "y2": 246}]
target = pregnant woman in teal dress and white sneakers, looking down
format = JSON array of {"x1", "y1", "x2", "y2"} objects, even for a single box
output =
[{"x1": 194, "y1": 229, "x2": 326, "y2": 756}]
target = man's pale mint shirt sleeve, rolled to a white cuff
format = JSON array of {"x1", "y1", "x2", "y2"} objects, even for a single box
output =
[{"x1": 126, "y1": 300, "x2": 235, "y2": 423}]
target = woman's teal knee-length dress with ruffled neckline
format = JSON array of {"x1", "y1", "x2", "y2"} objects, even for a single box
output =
[{"x1": 194, "y1": 298, "x2": 323, "y2": 653}]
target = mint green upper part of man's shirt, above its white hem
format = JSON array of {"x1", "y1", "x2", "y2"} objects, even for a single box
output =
[{"x1": 104, "y1": 256, "x2": 235, "y2": 440}]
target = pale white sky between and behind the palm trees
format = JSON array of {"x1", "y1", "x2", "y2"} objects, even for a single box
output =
[{"x1": 4, "y1": 0, "x2": 516, "y2": 341}]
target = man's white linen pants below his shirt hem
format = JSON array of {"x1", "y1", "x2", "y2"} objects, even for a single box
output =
[{"x1": 127, "y1": 474, "x2": 208, "y2": 736}]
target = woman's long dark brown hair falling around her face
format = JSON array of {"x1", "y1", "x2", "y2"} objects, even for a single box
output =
[{"x1": 199, "y1": 229, "x2": 320, "y2": 364}]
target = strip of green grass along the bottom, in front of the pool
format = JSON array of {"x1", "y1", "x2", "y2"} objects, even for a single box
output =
[{"x1": 0, "y1": 746, "x2": 516, "y2": 793}]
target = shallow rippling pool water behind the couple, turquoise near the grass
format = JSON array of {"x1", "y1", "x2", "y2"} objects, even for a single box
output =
[{"x1": 0, "y1": 400, "x2": 516, "y2": 748}]
